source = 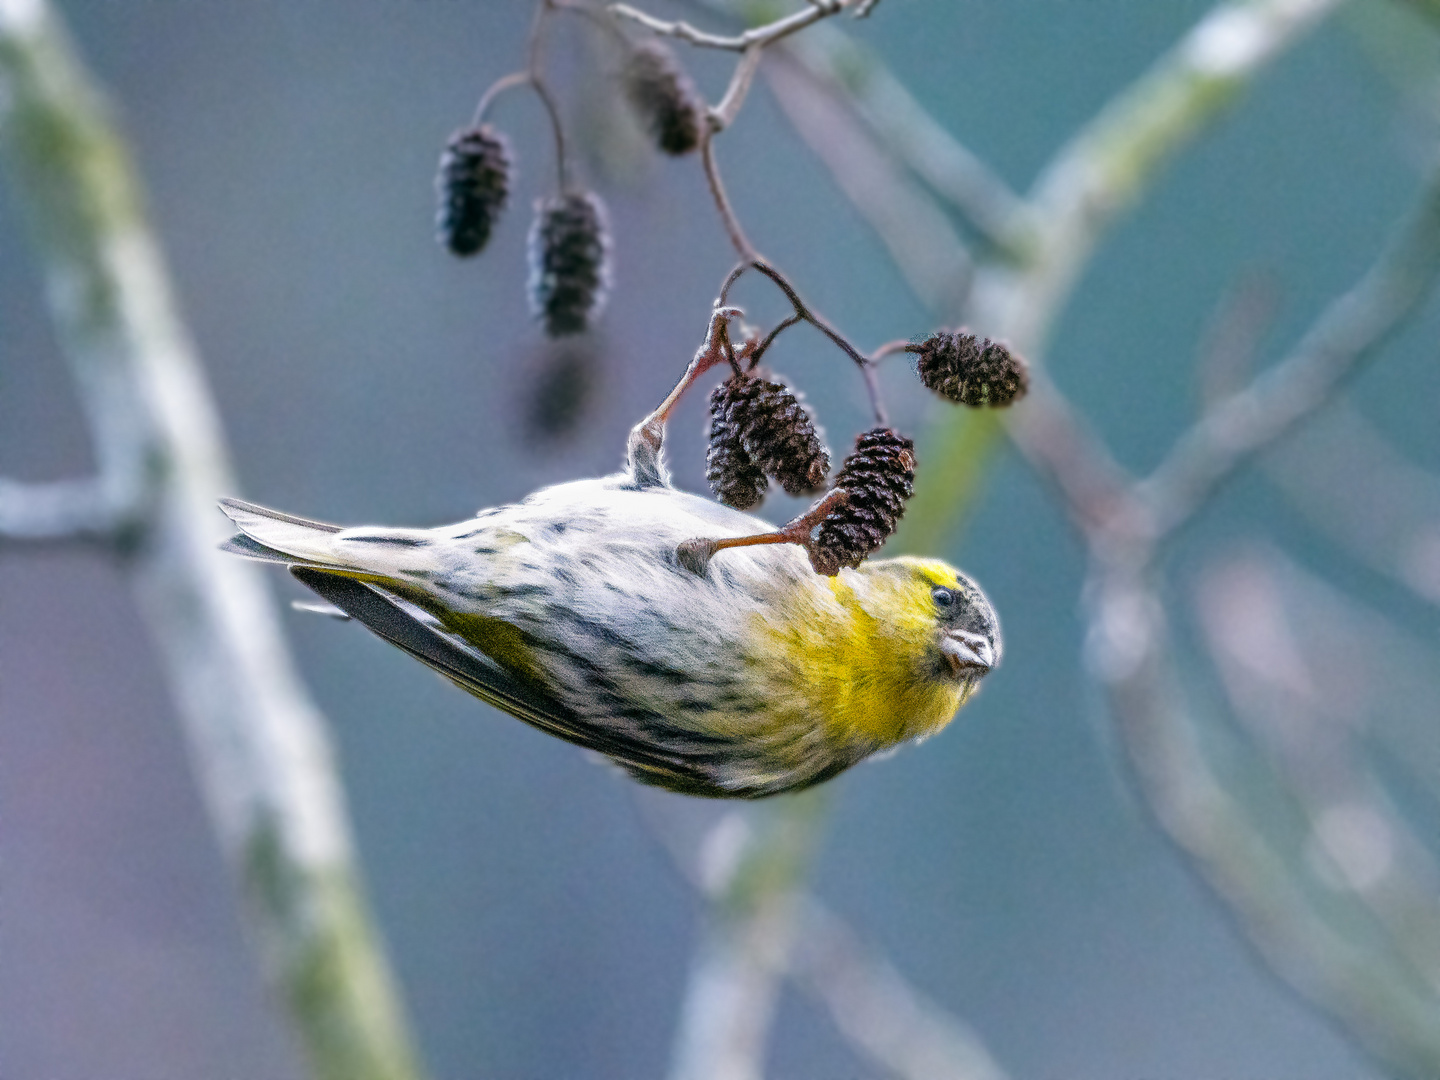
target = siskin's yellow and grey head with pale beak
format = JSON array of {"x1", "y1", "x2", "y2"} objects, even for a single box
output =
[{"x1": 858, "y1": 556, "x2": 1002, "y2": 696}]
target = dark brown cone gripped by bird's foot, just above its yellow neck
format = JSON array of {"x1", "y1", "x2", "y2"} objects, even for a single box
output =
[{"x1": 808, "y1": 428, "x2": 914, "y2": 577}]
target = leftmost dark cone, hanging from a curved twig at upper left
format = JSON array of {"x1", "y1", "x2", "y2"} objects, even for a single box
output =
[{"x1": 435, "y1": 124, "x2": 511, "y2": 258}]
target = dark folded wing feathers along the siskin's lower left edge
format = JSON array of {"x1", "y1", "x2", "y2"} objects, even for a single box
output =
[{"x1": 291, "y1": 566, "x2": 725, "y2": 792}]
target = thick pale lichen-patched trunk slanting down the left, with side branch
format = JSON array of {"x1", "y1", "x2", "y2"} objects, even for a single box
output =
[{"x1": 0, "y1": 0, "x2": 420, "y2": 1080}]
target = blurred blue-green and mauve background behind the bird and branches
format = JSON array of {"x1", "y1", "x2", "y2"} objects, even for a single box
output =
[{"x1": 0, "y1": 0, "x2": 1440, "y2": 1080}]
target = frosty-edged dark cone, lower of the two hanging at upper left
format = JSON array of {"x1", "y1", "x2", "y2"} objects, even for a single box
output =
[{"x1": 528, "y1": 192, "x2": 611, "y2": 337}]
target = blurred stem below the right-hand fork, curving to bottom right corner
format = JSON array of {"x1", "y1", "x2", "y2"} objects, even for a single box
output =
[{"x1": 1086, "y1": 566, "x2": 1440, "y2": 1077}]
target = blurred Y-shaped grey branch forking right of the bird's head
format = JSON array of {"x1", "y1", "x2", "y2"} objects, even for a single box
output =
[{"x1": 1011, "y1": 144, "x2": 1440, "y2": 1077}]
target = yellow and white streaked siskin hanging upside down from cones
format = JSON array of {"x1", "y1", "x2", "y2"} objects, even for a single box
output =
[{"x1": 220, "y1": 408, "x2": 1001, "y2": 798}]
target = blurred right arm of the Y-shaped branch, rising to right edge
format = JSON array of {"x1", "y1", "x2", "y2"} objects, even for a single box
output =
[{"x1": 1139, "y1": 167, "x2": 1440, "y2": 534}]
